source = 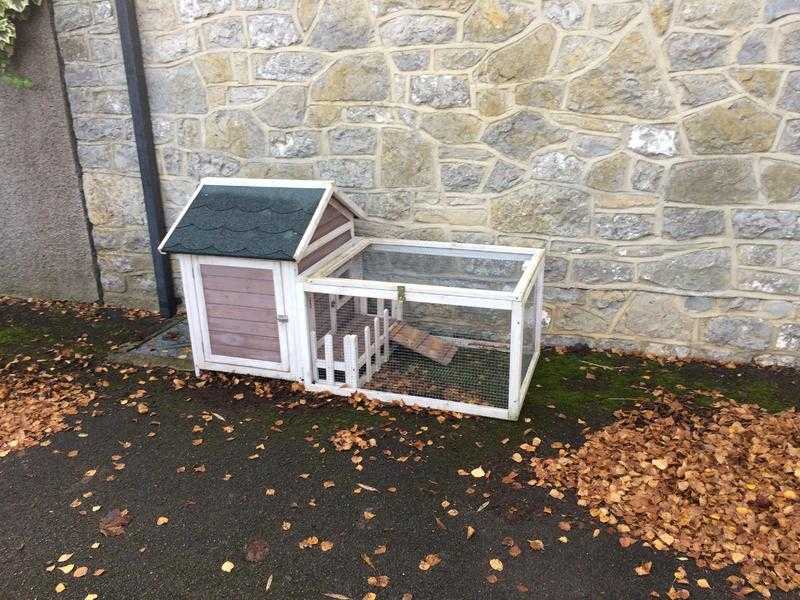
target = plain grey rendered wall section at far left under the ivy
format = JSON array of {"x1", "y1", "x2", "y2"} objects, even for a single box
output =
[{"x1": 0, "y1": 5, "x2": 98, "y2": 302}]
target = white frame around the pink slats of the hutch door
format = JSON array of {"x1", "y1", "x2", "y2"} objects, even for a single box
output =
[{"x1": 192, "y1": 255, "x2": 291, "y2": 372}]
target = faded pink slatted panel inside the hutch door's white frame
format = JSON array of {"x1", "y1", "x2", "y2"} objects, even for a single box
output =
[{"x1": 200, "y1": 265, "x2": 281, "y2": 362}]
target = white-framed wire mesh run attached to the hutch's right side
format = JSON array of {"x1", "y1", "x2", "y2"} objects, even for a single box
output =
[{"x1": 305, "y1": 240, "x2": 542, "y2": 418}]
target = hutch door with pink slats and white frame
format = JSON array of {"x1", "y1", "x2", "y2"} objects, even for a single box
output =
[{"x1": 195, "y1": 257, "x2": 290, "y2": 371}]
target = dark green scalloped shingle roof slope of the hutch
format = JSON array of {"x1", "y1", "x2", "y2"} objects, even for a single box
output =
[{"x1": 162, "y1": 185, "x2": 325, "y2": 260}]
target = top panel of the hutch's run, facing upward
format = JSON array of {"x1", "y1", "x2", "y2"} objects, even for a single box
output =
[{"x1": 333, "y1": 244, "x2": 531, "y2": 292}]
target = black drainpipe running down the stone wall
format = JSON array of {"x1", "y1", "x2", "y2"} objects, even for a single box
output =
[{"x1": 116, "y1": 0, "x2": 176, "y2": 318}]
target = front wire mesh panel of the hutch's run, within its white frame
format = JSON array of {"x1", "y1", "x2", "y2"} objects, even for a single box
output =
[{"x1": 309, "y1": 293, "x2": 511, "y2": 409}]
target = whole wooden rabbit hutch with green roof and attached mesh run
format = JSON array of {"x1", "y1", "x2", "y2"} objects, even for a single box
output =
[{"x1": 159, "y1": 178, "x2": 544, "y2": 420}]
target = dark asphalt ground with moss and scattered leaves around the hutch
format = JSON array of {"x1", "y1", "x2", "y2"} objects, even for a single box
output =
[{"x1": 0, "y1": 303, "x2": 798, "y2": 600}]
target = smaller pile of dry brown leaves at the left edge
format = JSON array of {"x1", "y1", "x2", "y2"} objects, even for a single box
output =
[{"x1": 0, "y1": 370, "x2": 95, "y2": 456}]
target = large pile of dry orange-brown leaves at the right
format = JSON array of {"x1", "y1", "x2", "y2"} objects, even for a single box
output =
[{"x1": 531, "y1": 395, "x2": 800, "y2": 596}]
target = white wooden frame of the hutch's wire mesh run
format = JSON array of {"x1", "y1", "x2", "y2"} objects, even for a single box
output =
[{"x1": 298, "y1": 238, "x2": 544, "y2": 420}]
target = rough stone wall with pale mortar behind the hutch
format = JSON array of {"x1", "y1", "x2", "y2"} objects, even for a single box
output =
[{"x1": 48, "y1": 0, "x2": 800, "y2": 366}]
